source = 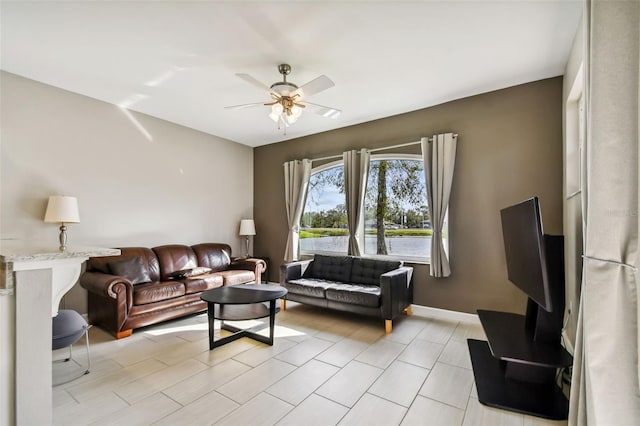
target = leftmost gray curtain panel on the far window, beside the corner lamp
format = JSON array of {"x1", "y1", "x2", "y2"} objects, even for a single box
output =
[{"x1": 284, "y1": 158, "x2": 311, "y2": 262}]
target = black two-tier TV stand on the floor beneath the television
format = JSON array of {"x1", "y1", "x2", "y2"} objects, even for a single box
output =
[{"x1": 467, "y1": 235, "x2": 572, "y2": 420}]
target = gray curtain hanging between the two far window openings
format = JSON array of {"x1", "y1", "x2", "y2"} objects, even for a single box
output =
[{"x1": 342, "y1": 148, "x2": 371, "y2": 256}]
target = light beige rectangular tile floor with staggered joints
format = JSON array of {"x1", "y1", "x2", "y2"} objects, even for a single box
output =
[{"x1": 53, "y1": 302, "x2": 566, "y2": 426}]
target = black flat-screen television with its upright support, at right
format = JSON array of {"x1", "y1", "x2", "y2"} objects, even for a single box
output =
[{"x1": 500, "y1": 197, "x2": 564, "y2": 340}]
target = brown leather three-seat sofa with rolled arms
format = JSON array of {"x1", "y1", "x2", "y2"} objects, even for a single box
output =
[{"x1": 80, "y1": 243, "x2": 266, "y2": 339}]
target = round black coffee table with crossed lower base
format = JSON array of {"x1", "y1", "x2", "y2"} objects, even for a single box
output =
[{"x1": 200, "y1": 284, "x2": 287, "y2": 350}]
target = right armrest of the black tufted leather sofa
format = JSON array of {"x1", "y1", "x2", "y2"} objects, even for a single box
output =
[{"x1": 380, "y1": 266, "x2": 413, "y2": 319}]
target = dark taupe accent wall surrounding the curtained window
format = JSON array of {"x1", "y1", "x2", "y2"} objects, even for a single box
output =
[{"x1": 254, "y1": 78, "x2": 563, "y2": 313}]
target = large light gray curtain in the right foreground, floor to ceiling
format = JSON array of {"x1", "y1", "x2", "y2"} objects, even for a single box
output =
[{"x1": 569, "y1": 0, "x2": 640, "y2": 425}]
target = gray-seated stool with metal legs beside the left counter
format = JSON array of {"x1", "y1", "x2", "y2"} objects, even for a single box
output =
[{"x1": 52, "y1": 309, "x2": 91, "y2": 386}]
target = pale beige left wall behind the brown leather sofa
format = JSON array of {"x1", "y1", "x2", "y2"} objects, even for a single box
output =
[{"x1": 0, "y1": 72, "x2": 253, "y2": 312}]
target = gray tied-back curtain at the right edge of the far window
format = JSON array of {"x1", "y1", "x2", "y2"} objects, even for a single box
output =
[{"x1": 421, "y1": 133, "x2": 458, "y2": 277}]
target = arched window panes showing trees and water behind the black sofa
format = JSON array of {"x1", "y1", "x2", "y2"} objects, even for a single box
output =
[{"x1": 300, "y1": 154, "x2": 447, "y2": 262}]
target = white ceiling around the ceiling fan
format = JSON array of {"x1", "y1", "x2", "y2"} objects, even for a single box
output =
[{"x1": 0, "y1": 0, "x2": 582, "y2": 146}]
